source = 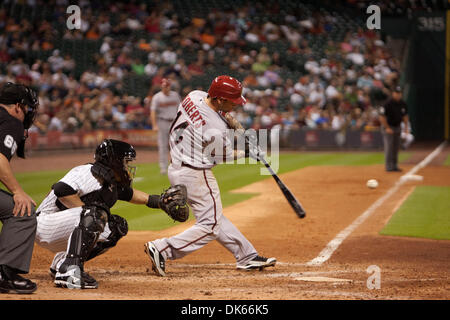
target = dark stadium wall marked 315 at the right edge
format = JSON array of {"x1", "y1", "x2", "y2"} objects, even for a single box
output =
[{"x1": 382, "y1": 11, "x2": 450, "y2": 140}]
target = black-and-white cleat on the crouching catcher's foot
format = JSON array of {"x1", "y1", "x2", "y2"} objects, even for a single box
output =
[{"x1": 54, "y1": 266, "x2": 98, "y2": 289}]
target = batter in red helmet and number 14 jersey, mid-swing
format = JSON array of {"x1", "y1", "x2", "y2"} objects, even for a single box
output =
[{"x1": 145, "y1": 76, "x2": 276, "y2": 276}]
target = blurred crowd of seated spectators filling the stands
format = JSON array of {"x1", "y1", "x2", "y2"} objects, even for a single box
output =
[{"x1": 0, "y1": 0, "x2": 408, "y2": 134}]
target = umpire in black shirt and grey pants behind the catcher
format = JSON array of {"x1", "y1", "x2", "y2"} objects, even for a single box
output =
[{"x1": 0, "y1": 82, "x2": 39, "y2": 293}]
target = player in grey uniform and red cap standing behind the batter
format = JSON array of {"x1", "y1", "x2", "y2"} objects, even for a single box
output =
[{"x1": 150, "y1": 78, "x2": 181, "y2": 174}]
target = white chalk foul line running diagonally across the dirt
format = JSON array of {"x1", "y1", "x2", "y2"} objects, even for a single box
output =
[{"x1": 306, "y1": 141, "x2": 447, "y2": 266}]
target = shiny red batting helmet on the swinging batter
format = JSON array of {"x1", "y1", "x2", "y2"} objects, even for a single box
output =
[{"x1": 208, "y1": 76, "x2": 247, "y2": 105}]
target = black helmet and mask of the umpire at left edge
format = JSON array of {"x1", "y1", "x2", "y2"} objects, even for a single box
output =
[{"x1": 0, "y1": 82, "x2": 39, "y2": 129}]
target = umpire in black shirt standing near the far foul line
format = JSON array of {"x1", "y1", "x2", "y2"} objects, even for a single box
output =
[{"x1": 380, "y1": 86, "x2": 408, "y2": 172}]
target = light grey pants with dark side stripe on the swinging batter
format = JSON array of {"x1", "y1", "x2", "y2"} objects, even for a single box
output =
[{"x1": 152, "y1": 164, "x2": 257, "y2": 265}]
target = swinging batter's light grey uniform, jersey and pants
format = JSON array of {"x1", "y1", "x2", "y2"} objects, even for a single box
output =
[{"x1": 152, "y1": 91, "x2": 257, "y2": 265}]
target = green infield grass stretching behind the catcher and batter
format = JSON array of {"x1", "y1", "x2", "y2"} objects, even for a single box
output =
[{"x1": 3, "y1": 152, "x2": 410, "y2": 230}]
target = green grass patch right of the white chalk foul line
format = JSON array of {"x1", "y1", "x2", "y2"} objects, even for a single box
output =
[{"x1": 380, "y1": 186, "x2": 450, "y2": 240}]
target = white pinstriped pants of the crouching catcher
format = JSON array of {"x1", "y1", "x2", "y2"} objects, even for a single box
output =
[{"x1": 35, "y1": 207, "x2": 111, "y2": 269}]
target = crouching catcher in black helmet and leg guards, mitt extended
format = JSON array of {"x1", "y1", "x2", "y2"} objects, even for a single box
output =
[{"x1": 36, "y1": 139, "x2": 189, "y2": 289}]
